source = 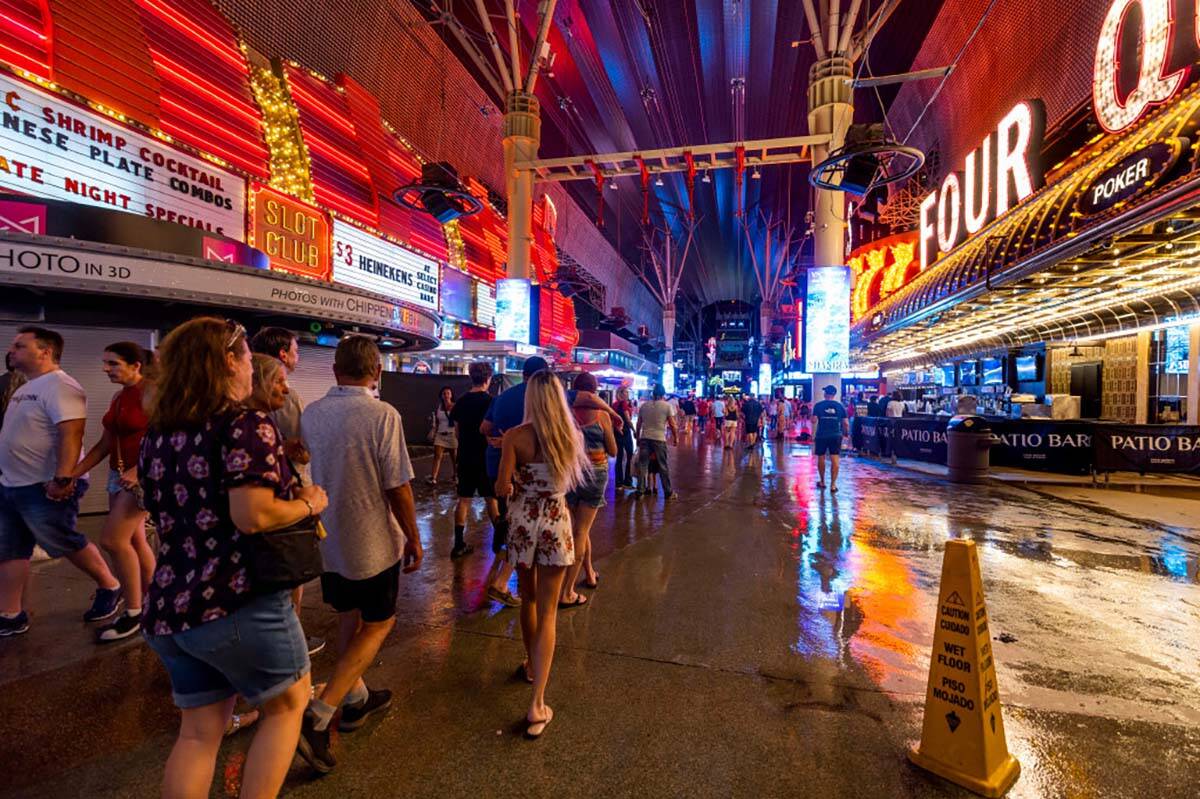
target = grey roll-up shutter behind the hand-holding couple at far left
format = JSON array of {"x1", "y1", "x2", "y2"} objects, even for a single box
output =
[{"x1": 0, "y1": 320, "x2": 157, "y2": 513}]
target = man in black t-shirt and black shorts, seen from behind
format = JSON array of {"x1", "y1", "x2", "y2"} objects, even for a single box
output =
[{"x1": 450, "y1": 361, "x2": 521, "y2": 607}]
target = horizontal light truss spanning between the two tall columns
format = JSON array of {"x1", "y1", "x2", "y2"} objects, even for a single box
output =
[{"x1": 514, "y1": 134, "x2": 829, "y2": 181}]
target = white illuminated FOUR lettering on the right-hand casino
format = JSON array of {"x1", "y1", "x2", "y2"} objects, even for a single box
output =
[{"x1": 919, "y1": 100, "x2": 1045, "y2": 270}]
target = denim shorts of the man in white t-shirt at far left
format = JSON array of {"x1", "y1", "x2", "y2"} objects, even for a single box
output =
[{"x1": 0, "y1": 479, "x2": 88, "y2": 560}]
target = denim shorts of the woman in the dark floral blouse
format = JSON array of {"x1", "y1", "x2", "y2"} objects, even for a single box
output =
[{"x1": 145, "y1": 591, "x2": 310, "y2": 709}]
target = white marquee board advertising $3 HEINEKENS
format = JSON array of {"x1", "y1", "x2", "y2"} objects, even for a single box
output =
[{"x1": 334, "y1": 220, "x2": 440, "y2": 311}]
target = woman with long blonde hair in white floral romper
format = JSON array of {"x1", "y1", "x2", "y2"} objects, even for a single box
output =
[{"x1": 496, "y1": 371, "x2": 590, "y2": 738}]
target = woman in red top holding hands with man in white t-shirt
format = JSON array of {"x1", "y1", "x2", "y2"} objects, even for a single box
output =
[{"x1": 74, "y1": 341, "x2": 155, "y2": 643}]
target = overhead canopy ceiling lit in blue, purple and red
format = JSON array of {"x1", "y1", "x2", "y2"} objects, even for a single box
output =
[{"x1": 409, "y1": 0, "x2": 942, "y2": 305}]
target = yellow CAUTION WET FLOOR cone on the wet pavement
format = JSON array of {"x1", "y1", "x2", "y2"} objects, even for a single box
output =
[{"x1": 908, "y1": 539, "x2": 1021, "y2": 797}]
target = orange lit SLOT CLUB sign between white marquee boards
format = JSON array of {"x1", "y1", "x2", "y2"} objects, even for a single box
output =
[{"x1": 247, "y1": 184, "x2": 330, "y2": 281}]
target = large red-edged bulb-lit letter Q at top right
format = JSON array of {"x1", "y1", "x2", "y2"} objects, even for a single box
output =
[{"x1": 1092, "y1": 0, "x2": 1187, "y2": 133}]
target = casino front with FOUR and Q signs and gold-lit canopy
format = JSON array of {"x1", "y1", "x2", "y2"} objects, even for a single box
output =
[{"x1": 853, "y1": 2, "x2": 1200, "y2": 471}]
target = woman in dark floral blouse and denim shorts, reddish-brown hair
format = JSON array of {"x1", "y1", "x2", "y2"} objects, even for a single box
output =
[{"x1": 139, "y1": 317, "x2": 328, "y2": 797}]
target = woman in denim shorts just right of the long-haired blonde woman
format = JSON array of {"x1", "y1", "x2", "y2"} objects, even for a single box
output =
[{"x1": 562, "y1": 372, "x2": 617, "y2": 599}]
